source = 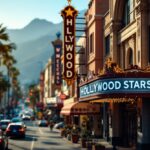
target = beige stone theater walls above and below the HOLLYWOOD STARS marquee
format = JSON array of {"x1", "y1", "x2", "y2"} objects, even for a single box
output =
[{"x1": 104, "y1": 0, "x2": 150, "y2": 150}]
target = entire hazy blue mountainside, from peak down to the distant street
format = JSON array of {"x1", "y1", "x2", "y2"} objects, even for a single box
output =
[{"x1": 7, "y1": 10, "x2": 85, "y2": 83}]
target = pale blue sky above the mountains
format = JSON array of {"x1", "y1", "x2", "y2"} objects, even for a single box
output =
[{"x1": 0, "y1": 0, "x2": 89, "y2": 29}]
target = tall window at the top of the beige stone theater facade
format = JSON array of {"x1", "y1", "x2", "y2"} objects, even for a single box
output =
[{"x1": 123, "y1": 0, "x2": 134, "y2": 26}]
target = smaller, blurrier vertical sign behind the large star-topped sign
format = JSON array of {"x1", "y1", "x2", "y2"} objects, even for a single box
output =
[{"x1": 55, "y1": 45, "x2": 62, "y2": 85}]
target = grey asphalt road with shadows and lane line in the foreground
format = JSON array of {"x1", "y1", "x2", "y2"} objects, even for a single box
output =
[{"x1": 9, "y1": 122, "x2": 81, "y2": 150}]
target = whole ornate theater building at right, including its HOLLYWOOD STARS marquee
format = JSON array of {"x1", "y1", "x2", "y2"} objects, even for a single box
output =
[{"x1": 79, "y1": 0, "x2": 150, "y2": 150}]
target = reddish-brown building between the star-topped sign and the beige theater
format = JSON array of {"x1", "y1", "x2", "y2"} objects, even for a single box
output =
[{"x1": 85, "y1": 0, "x2": 109, "y2": 74}]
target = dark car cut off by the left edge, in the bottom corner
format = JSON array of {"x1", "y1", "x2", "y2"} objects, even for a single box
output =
[{"x1": 0, "y1": 130, "x2": 8, "y2": 150}]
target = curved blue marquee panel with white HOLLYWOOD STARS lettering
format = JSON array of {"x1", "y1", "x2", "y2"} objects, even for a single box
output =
[{"x1": 80, "y1": 78, "x2": 150, "y2": 98}]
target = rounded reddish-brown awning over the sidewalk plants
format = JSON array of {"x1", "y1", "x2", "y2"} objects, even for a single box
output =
[{"x1": 60, "y1": 102, "x2": 100, "y2": 115}]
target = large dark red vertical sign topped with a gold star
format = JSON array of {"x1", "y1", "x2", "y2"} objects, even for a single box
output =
[{"x1": 61, "y1": 5, "x2": 78, "y2": 85}]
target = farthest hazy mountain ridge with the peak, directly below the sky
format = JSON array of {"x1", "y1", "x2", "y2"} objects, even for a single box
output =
[{"x1": 8, "y1": 18, "x2": 62, "y2": 43}]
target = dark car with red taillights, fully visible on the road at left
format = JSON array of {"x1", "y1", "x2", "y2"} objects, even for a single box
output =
[{"x1": 6, "y1": 123, "x2": 25, "y2": 138}]
